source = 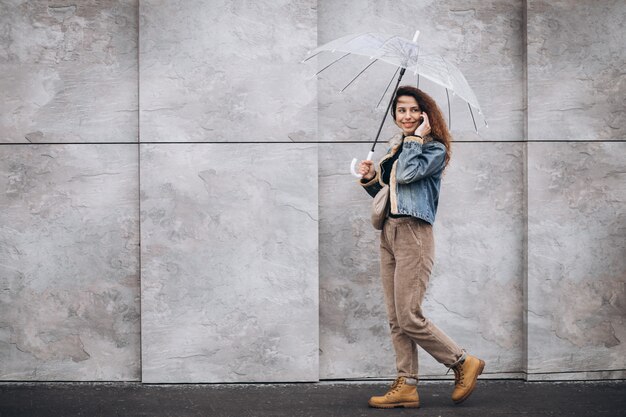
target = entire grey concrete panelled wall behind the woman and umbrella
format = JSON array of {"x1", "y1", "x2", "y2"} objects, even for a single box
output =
[{"x1": 0, "y1": 0, "x2": 626, "y2": 382}]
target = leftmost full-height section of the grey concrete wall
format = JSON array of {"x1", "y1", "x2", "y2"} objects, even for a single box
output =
[{"x1": 0, "y1": 0, "x2": 141, "y2": 381}]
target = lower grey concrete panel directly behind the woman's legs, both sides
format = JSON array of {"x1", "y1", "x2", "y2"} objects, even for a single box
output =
[{"x1": 320, "y1": 143, "x2": 524, "y2": 378}]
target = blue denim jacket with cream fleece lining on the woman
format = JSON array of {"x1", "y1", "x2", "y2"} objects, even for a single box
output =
[{"x1": 361, "y1": 136, "x2": 446, "y2": 224}]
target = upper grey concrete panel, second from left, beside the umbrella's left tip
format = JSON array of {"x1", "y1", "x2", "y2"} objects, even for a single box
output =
[{"x1": 140, "y1": 0, "x2": 317, "y2": 142}]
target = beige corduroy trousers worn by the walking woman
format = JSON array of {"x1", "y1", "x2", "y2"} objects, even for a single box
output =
[{"x1": 380, "y1": 217, "x2": 465, "y2": 378}]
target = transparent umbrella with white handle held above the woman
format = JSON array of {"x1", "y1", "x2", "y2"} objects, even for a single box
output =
[{"x1": 304, "y1": 31, "x2": 487, "y2": 178}]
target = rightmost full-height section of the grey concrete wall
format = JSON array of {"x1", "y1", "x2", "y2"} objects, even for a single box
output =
[{"x1": 527, "y1": 0, "x2": 626, "y2": 380}]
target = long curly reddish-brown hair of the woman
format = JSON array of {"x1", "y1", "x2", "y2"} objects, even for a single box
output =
[{"x1": 391, "y1": 85, "x2": 452, "y2": 166}]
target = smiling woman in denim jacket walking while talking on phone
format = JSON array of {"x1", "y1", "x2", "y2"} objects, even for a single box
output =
[{"x1": 359, "y1": 86, "x2": 485, "y2": 408}]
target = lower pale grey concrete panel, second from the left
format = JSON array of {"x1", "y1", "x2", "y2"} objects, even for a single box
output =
[{"x1": 141, "y1": 144, "x2": 318, "y2": 382}]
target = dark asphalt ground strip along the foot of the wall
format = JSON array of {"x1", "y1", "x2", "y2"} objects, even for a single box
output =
[{"x1": 0, "y1": 380, "x2": 626, "y2": 417}]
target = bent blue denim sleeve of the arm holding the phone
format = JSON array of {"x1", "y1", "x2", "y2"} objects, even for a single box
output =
[{"x1": 396, "y1": 136, "x2": 446, "y2": 184}]
